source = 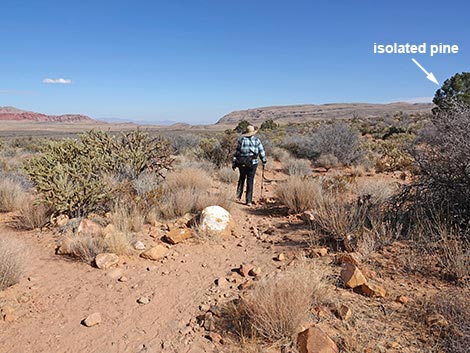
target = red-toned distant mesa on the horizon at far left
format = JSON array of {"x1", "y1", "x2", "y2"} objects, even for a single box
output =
[{"x1": 0, "y1": 107, "x2": 96, "y2": 123}]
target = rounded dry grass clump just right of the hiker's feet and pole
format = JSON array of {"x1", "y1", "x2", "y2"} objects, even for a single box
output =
[{"x1": 275, "y1": 176, "x2": 322, "y2": 213}]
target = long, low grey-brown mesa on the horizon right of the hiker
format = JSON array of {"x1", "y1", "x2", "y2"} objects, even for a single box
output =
[{"x1": 216, "y1": 102, "x2": 434, "y2": 125}]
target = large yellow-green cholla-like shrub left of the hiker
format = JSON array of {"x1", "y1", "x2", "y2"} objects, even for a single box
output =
[{"x1": 25, "y1": 130, "x2": 172, "y2": 217}]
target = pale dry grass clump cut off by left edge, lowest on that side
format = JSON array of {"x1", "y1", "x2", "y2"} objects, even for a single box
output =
[{"x1": 0, "y1": 236, "x2": 24, "y2": 291}]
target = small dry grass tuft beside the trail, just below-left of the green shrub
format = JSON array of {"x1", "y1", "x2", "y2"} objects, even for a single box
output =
[{"x1": 8, "y1": 199, "x2": 51, "y2": 230}]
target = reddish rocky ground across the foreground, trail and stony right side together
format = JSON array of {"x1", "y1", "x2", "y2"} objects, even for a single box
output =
[{"x1": 0, "y1": 166, "x2": 464, "y2": 353}]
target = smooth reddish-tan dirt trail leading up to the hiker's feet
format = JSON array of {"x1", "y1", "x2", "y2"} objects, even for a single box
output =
[{"x1": 0, "y1": 191, "x2": 280, "y2": 353}]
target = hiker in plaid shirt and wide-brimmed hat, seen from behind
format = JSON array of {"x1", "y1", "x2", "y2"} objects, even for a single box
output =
[{"x1": 232, "y1": 125, "x2": 266, "y2": 206}]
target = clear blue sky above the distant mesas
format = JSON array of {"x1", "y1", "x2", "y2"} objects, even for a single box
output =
[{"x1": 0, "y1": 0, "x2": 470, "y2": 123}]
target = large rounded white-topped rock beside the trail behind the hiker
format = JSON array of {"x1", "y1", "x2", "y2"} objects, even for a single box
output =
[{"x1": 199, "y1": 206, "x2": 235, "y2": 239}]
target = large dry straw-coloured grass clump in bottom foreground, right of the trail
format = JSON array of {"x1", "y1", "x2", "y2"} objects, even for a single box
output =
[{"x1": 225, "y1": 261, "x2": 329, "y2": 347}]
